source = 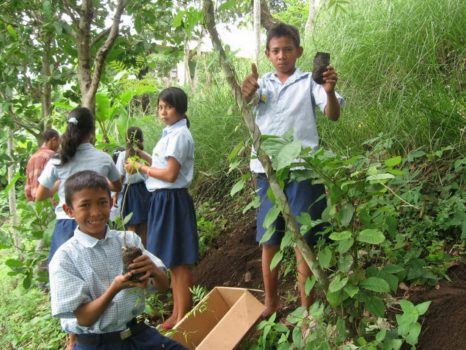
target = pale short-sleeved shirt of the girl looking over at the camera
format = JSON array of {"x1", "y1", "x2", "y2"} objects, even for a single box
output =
[{"x1": 146, "y1": 119, "x2": 194, "y2": 192}]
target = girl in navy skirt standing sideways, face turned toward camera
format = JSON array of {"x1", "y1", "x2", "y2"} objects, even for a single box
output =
[{"x1": 125, "y1": 87, "x2": 199, "y2": 329}]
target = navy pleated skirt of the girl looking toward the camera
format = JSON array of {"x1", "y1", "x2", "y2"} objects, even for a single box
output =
[{"x1": 147, "y1": 188, "x2": 199, "y2": 268}]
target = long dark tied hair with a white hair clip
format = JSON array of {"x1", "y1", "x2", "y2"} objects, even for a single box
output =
[{"x1": 59, "y1": 107, "x2": 95, "y2": 165}]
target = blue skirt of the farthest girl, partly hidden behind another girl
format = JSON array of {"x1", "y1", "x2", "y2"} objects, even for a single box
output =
[{"x1": 121, "y1": 181, "x2": 151, "y2": 226}]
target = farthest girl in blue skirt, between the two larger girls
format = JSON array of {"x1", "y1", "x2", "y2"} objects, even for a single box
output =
[{"x1": 114, "y1": 127, "x2": 150, "y2": 246}]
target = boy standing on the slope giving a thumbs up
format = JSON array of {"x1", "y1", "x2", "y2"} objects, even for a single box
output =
[{"x1": 241, "y1": 23, "x2": 343, "y2": 317}]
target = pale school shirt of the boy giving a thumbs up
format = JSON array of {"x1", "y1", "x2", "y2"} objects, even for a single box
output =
[{"x1": 250, "y1": 68, "x2": 344, "y2": 173}]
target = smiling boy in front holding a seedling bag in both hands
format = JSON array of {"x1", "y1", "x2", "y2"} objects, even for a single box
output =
[{"x1": 49, "y1": 170, "x2": 185, "y2": 350}]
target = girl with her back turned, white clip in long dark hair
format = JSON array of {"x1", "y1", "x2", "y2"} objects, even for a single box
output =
[{"x1": 36, "y1": 107, "x2": 121, "y2": 261}]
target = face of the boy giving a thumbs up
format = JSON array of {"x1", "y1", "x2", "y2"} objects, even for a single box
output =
[{"x1": 265, "y1": 36, "x2": 303, "y2": 76}]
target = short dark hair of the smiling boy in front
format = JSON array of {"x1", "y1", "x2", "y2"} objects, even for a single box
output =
[{"x1": 65, "y1": 170, "x2": 110, "y2": 207}]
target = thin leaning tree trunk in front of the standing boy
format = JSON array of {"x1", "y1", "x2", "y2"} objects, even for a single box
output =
[{"x1": 203, "y1": 0, "x2": 329, "y2": 293}]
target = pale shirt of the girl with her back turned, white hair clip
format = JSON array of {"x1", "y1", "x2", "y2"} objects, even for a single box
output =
[{"x1": 39, "y1": 143, "x2": 120, "y2": 220}]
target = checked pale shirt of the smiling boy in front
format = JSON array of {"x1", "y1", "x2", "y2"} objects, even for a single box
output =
[{"x1": 49, "y1": 227, "x2": 165, "y2": 334}]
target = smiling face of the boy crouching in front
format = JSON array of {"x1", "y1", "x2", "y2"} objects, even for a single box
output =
[{"x1": 63, "y1": 188, "x2": 112, "y2": 239}]
